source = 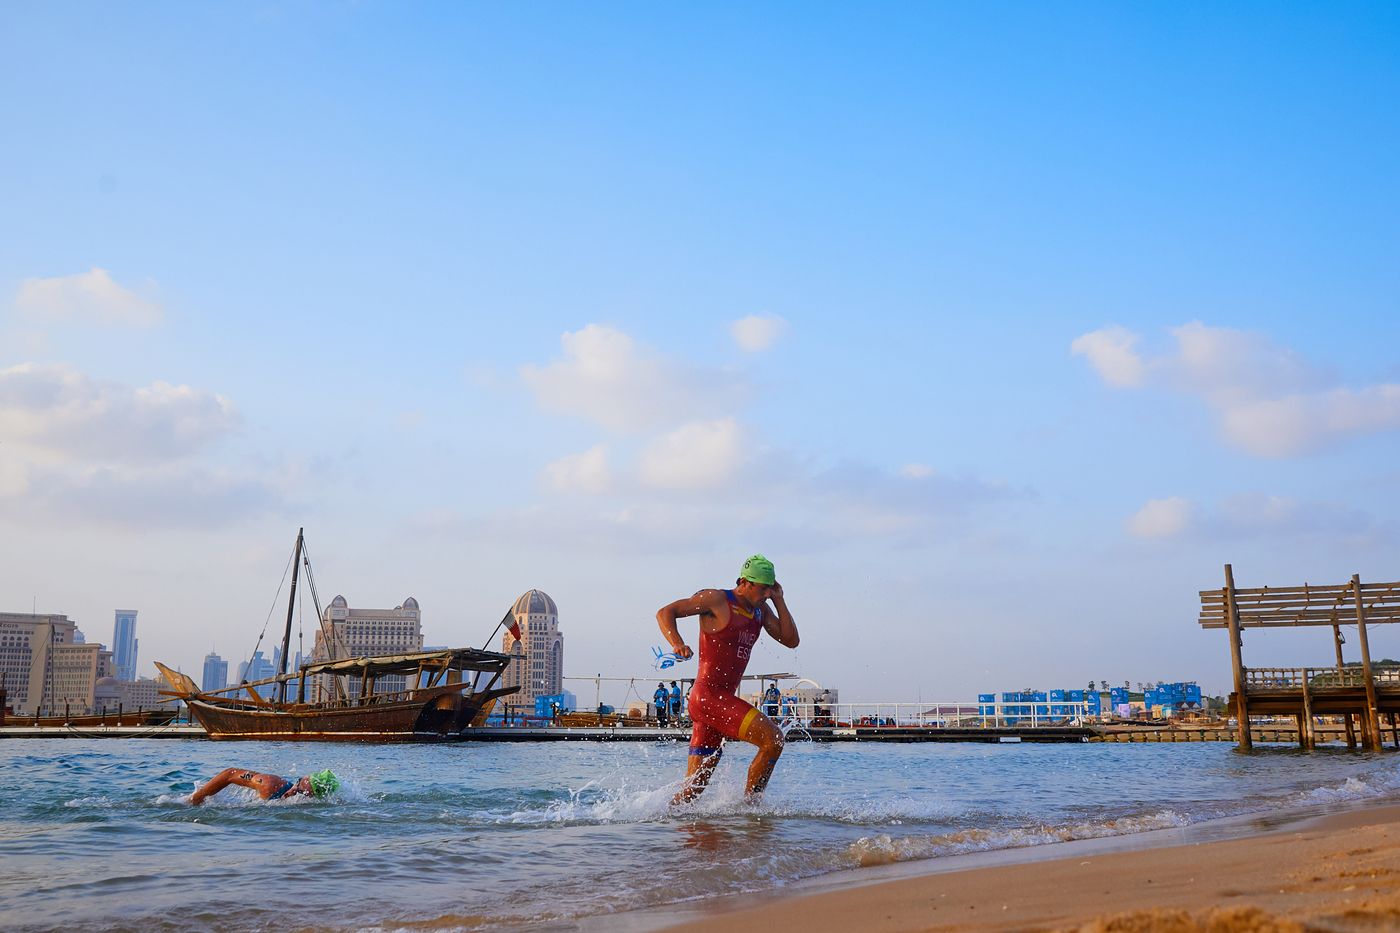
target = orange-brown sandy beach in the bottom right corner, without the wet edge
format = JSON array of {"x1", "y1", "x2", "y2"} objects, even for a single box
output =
[{"x1": 666, "y1": 807, "x2": 1400, "y2": 933}]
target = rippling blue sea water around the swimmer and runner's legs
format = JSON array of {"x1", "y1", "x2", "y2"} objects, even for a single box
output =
[{"x1": 0, "y1": 738, "x2": 1400, "y2": 932}]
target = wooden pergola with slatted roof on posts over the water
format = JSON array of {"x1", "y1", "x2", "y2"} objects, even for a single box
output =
[{"x1": 1200, "y1": 563, "x2": 1400, "y2": 751}]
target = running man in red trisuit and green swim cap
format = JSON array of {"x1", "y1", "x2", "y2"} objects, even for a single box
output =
[{"x1": 657, "y1": 553, "x2": 798, "y2": 803}]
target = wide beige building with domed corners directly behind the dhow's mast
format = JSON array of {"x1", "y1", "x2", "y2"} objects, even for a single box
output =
[{"x1": 311, "y1": 595, "x2": 423, "y2": 699}]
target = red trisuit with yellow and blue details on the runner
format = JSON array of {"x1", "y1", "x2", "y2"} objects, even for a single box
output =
[{"x1": 689, "y1": 590, "x2": 763, "y2": 756}]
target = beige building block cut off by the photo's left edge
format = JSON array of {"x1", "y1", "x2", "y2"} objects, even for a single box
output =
[{"x1": 0, "y1": 612, "x2": 105, "y2": 714}]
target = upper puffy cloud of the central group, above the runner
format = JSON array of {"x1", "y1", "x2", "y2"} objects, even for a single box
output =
[{"x1": 521, "y1": 324, "x2": 739, "y2": 431}]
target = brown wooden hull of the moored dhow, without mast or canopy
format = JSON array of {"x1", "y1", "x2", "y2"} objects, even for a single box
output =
[{"x1": 186, "y1": 685, "x2": 517, "y2": 742}]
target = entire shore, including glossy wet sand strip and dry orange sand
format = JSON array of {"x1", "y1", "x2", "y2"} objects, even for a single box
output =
[{"x1": 574, "y1": 803, "x2": 1400, "y2": 933}]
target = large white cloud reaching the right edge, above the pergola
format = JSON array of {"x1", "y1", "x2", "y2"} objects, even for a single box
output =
[{"x1": 1071, "y1": 321, "x2": 1400, "y2": 457}]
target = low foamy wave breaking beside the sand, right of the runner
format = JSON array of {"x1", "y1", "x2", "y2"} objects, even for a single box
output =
[{"x1": 847, "y1": 810, "x2": 1191, "y2": 867}]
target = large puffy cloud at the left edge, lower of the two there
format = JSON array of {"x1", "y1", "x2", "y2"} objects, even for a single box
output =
[{"x1": 0, "y1": 363, "x2": 238, "y2": 462}]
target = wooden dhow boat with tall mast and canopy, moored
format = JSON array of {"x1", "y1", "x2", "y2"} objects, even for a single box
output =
[{"x1": 155, "y1": 531, "x2": 519, "y2": 742}]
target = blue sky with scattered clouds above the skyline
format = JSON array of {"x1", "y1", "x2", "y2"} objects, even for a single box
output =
[{"x1": 0, "y1": 1, "x2": 1400, "y2": 702}]
